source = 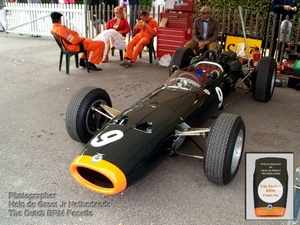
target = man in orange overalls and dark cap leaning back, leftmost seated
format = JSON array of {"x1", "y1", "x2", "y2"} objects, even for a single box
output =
[{"x1": 50, "y1": 12, "x2": 105, "y2": 71}]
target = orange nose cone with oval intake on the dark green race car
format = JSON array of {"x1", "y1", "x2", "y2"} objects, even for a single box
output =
[{"x1": 70, "y1": 155, "x2": 127, "y2": 195}]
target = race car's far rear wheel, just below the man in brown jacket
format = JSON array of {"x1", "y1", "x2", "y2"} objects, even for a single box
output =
[{"x1": 169, "y1": 47, "x2": 195, "y2": 76}]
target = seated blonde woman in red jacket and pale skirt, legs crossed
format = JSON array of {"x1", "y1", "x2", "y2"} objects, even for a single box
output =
[{"x1": 94, "y1": 6, "x2": 130, "y2": 63}]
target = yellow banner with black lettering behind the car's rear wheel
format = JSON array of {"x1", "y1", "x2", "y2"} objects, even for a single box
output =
[{"x1": 225, "y1": 35, "x2": 262, "y2": 58}]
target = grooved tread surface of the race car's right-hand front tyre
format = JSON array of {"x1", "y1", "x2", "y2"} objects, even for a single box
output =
[{"x1": 204, "y1": 113, "x2": 239, "y2": 184}]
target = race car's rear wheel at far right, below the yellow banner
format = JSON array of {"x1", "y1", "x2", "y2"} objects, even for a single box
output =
[{"x1": 253, "y1": 57, "x2": 277, "y2": 102}]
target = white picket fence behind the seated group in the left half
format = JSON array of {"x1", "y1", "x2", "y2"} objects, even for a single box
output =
[{"x1": 5, "y1": 3, "x2": 162, "y2": 38}]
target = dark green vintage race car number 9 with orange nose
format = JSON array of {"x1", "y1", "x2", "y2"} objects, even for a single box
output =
[{"x1": 66, "y1": 47, "x2": 276, "y2": 194}]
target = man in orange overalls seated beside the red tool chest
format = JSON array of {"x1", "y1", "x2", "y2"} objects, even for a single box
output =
[{"x1": 120, "y1": 11, "x2": 158, "y2": 67}]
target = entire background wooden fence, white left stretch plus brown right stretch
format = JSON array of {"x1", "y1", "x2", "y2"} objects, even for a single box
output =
[{"x1": 6, "y1": 3, "x2": 300, "y2": 59}]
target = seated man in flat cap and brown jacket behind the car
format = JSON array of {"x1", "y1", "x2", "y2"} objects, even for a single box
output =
[{"x1": 185, "y1": 6, "x2": 219, "y2": 52}]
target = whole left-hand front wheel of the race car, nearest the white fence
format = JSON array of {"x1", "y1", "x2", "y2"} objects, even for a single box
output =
[{"x1": 66, "y1": 87, "x2": 112, "y2": 143}]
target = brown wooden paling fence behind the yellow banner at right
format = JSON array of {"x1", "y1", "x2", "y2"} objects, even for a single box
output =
[{"x1": 214, "y1": 9, "x2": 300, "y2": 61}]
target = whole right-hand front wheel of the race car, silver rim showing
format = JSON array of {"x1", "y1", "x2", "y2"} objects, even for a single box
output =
[{"x1": 203, "y1": 113, "x2": 245, "y2": 185}]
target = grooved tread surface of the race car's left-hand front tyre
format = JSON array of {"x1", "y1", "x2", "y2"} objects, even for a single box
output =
[{"x1": 66, "y1": 87, "x2": 97, "y2": 142}]
